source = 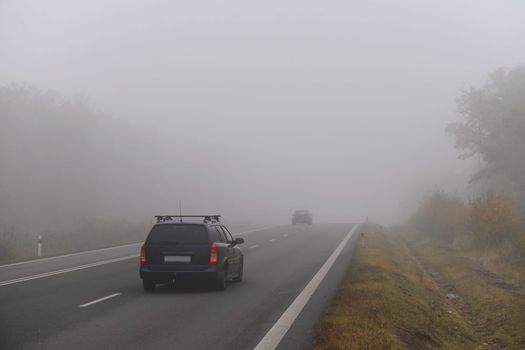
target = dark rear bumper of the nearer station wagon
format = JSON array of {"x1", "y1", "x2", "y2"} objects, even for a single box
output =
[{"x1": 140, "y1": 265, "x2": 221, "y2": 282}]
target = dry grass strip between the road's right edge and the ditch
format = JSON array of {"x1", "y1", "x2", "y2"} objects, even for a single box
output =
[{"x1": 315, "y1": 225, "x2": 480, "y2": 350}]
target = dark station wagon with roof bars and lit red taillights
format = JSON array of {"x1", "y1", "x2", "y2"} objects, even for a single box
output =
[{"x1": 140, "y1": 215, "x2": 244, "y2": 292}]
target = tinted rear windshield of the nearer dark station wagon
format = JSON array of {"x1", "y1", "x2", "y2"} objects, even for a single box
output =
[{"x1": 148, "y1": 224, "x2": 209, "y2": 244}]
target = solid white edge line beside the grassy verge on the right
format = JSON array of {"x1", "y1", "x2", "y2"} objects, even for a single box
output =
[{"x1": 254, "y1": 224, "x2": 360, "y2": 350}]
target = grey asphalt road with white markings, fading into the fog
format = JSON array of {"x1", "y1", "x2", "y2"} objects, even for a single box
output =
[{"x1": 0, "y1": 224, "x2": 358, "y2": 350}]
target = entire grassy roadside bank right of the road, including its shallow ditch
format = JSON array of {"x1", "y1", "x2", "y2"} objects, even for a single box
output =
[{"x1": 315, "y1": 224, "x2": 525, "y2": 350}]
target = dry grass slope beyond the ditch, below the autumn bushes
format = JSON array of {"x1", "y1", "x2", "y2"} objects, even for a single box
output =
[{"x1": 412, "y1": 240, "x2": 525, "y2": 349}]
